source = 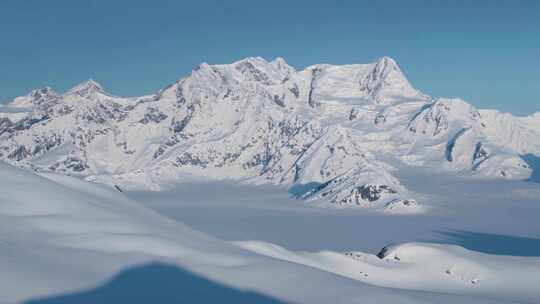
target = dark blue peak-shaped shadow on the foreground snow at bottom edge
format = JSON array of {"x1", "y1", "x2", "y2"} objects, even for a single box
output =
[{"x1": 26, "y1": 263, "x2": 283, "y2": 304}]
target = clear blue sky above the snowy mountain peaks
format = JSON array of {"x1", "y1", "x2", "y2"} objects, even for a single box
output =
[{"x1": 0, "y1": 0, "x2": 540, "y2": 114}]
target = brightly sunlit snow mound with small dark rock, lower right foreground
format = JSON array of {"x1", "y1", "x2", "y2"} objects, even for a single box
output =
[{"x1": 238, "y1": 241, "x2": 540, "y2": 303}]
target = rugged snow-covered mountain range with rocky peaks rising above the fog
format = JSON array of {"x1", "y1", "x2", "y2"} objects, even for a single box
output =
[{"x1": 0, "y1": 57, "x2": 540, "y2": 211}]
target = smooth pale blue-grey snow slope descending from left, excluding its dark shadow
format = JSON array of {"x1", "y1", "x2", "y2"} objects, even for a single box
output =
[{"x1": 0, "y1": 163, "x2": 510, "y2": 303}]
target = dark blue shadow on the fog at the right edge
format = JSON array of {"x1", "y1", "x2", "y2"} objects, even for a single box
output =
[{"x1": 435, "y1": 230, "x2": 540, "y2": 256}]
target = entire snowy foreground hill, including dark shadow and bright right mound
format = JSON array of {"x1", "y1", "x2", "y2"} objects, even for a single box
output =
[{"x1": 0, "y1": 163, "x2": 540, "y2": 304}]
